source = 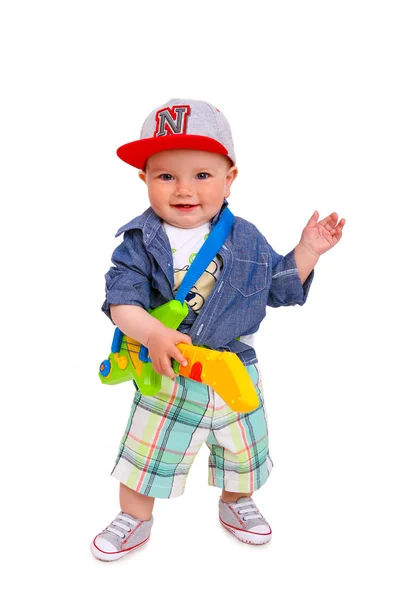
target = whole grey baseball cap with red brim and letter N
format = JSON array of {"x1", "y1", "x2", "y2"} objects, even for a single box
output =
[{"x1": 117, "y1": 98, "x2": 236, "y2": 169}]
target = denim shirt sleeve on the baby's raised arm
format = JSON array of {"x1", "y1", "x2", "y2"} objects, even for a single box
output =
[{"x1": 267, "y1": 246, "x2": 314, "y2": 307}]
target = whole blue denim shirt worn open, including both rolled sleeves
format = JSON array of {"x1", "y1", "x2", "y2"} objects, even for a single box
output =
[{"x1": 102, "y1": 200, "x2": 314, "y2": 365}]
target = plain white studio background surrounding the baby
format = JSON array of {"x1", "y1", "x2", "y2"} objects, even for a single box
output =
[{"x1": 0, "y1": 0, "x2": 400, "y2": 600}]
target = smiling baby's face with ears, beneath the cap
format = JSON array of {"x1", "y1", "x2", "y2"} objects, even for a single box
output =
[{"x1": 139, "y1": 150, "x2": 237, "y2": 229}]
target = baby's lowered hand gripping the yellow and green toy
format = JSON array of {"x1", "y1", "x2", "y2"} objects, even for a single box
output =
[{"x1": 147, "y1": 323, "x2": 192, "y2": 379}]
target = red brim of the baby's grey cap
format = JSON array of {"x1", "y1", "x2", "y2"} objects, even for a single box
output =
[{"x1": 117, "y1": 134, "x2": 228, "y2": 169}]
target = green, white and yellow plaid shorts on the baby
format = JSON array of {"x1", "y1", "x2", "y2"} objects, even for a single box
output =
[{"x1": 111, "y1": 365, "x2": 272, "y2": 498}]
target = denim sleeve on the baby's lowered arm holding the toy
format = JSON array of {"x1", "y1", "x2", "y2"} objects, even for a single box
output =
[{"x1": 101, "y1": 230, "x2": 151, "y2": 320}]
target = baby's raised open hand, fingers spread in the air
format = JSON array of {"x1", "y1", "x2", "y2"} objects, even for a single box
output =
[{"x1": 300, "y1": 210, "x2": 346, "y2": 256}]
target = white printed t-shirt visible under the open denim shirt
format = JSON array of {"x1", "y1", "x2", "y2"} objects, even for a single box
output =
[{"x1": 162, "y1": 222, "x2": 222, "y2": 313}]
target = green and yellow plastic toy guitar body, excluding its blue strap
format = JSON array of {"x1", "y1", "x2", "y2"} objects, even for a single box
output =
[{"x1": 99, "y1": 300, "x2": 258, "y2": 412}]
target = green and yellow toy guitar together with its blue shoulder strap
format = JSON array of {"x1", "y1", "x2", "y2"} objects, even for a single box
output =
[{"x1": 99, "y1": 208, "x2": 258, "y2": 412}]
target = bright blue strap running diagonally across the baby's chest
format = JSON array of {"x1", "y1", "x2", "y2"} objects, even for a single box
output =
[{"x1": 175, "y1": 208, "x2": 235, "y2": 304}]
